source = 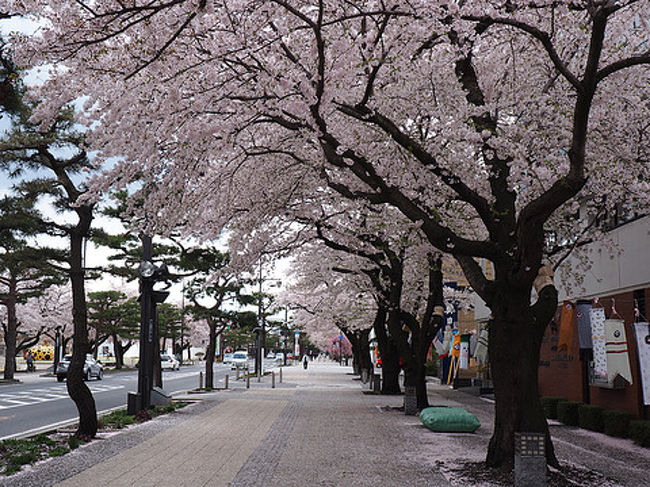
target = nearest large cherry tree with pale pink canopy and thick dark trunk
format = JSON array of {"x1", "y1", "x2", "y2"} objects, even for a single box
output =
[{"x1": 15, "y1": 0, "x2": 650, "y2": 466}]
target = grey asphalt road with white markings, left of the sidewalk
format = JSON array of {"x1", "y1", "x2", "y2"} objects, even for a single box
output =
[{"x1": 0, "y1": 364, "x2": 232, "y2": 440}]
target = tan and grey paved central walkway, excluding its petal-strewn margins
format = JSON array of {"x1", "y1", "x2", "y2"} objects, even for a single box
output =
[{"x1": 45, "y1": 362, "x2": 450, "y2": 487}]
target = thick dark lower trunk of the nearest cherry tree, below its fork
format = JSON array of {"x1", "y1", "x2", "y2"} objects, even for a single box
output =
[{"x1": 486, "y1": 286, "x2": 558, "y2": 467}]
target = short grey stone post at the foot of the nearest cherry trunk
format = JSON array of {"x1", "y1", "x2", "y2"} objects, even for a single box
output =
[{"x1": 515, "y1": 433, "x2": 547, "y2": 487}]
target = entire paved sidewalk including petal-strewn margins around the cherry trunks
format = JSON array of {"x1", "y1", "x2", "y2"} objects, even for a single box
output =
[{"x1": 6, "y1": 362, "x2": 650, "y2": 487}]
